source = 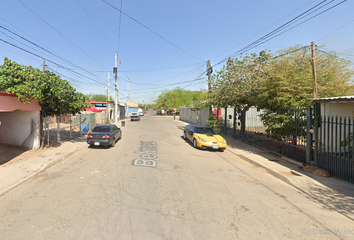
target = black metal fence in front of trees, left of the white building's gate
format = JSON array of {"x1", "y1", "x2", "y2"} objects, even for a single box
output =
[{"x1": 227, "y1": 107, "x2": 307, "y2": 162}]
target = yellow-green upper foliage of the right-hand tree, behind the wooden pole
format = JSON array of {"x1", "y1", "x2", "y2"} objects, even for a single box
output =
[{"x1": 257, "y1": 45, "x2": 354, "y2": 110}]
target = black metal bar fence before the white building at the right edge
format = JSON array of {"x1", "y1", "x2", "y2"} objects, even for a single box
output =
[{"x1": 315, "y1": 116, "x2": 354, "y2": 183}]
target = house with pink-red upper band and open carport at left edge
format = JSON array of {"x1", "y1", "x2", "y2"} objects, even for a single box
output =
[{"x1": 0, "y1": 92, "x2": 41, "y2": 149}]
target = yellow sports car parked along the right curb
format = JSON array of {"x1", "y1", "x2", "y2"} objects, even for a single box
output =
[{"x1": 183, "y1": 125, "x2": 227, "y2": 152}]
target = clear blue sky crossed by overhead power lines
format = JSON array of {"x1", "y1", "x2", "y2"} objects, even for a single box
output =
[{"x1": 0, "y1": 0, "x2": 354, "y2": 103}]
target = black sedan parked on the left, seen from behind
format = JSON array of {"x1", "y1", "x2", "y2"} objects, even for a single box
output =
[{"x1": 87, "y1": 124, "x2": 122, "y2": 147}]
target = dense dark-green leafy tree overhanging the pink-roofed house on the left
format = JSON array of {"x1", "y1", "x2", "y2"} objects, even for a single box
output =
[{"x1": 0, "y1": 58, "x2": 88, "y2": 116}]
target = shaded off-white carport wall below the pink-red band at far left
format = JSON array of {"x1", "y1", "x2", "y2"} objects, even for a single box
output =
[{"x1": 0, "y1": 110, "x2": 40, "y2": 149}]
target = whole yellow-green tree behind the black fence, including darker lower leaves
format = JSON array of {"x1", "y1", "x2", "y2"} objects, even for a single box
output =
[{"x1": 256, "y1": 45, "x2": 354, "y2": 142}]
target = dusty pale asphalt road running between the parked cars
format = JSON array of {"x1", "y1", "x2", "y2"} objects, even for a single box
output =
[{"x1": 0, "y1": 112, "x2": 354, "y2": 240}]
